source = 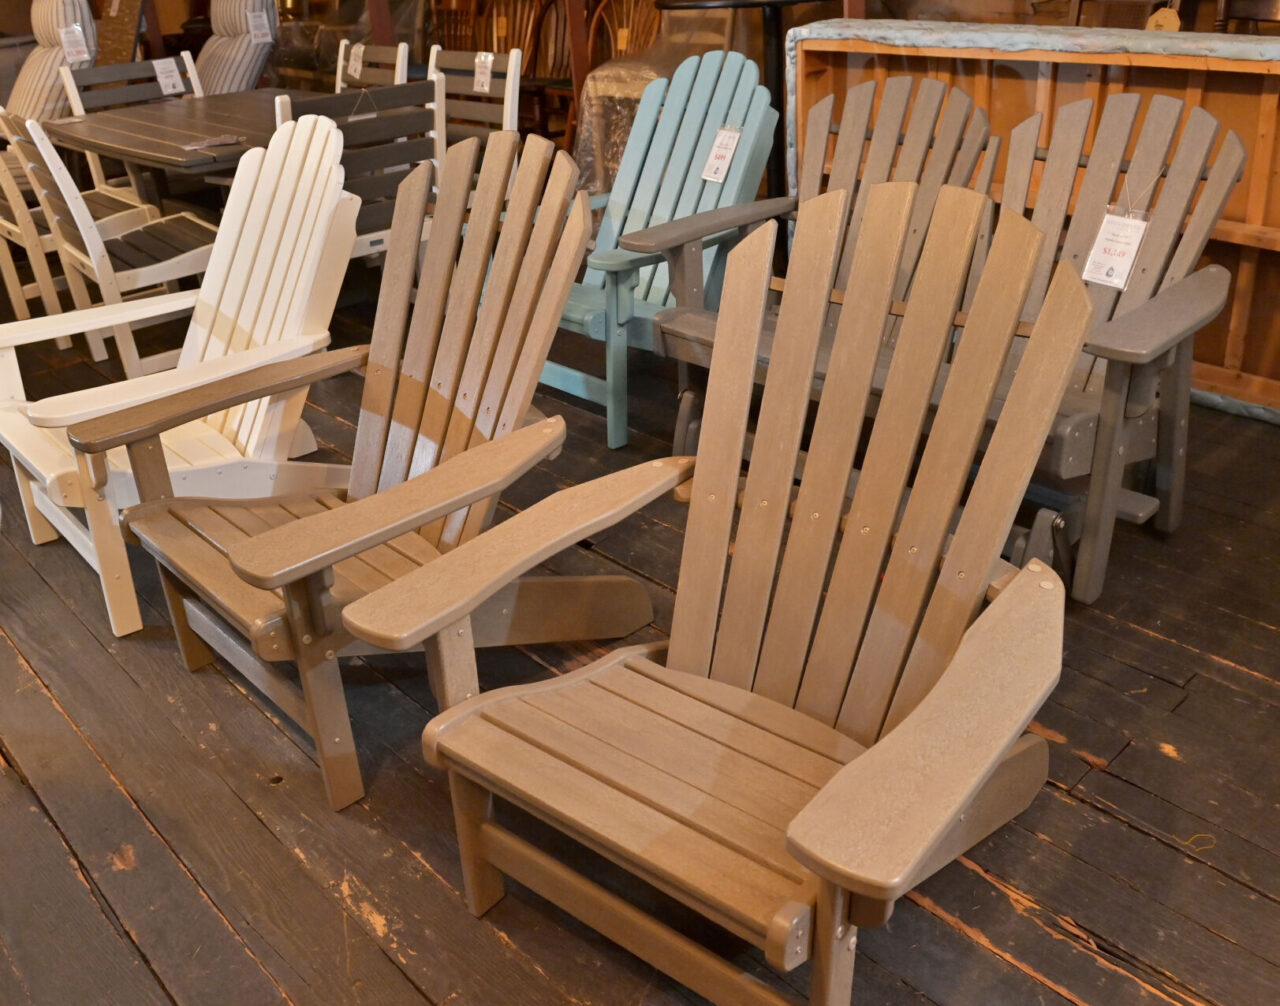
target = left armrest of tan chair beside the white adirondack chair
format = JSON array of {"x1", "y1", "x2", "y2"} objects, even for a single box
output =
[{"x1": 67, "y1": 346, "x2": 369, "y2": 454}]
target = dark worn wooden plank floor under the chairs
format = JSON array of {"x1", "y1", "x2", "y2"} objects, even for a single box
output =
[{"x1": 0, "y1": 312, "x2": 1280, "y2": 1006}]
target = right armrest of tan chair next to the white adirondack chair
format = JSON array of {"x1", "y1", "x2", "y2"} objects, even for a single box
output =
[{"x1": 227, "y1": 416, "x2": 564, "y2": 590}]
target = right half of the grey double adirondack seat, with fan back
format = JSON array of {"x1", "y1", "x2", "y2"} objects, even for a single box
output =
[{"x1": 977, "y1": 93, "x2": 1244, "y2": 603}]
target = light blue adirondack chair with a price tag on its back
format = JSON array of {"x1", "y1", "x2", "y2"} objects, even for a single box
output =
[{"x1": 543, "y1": 51, "x2": 778, "y2": 447}]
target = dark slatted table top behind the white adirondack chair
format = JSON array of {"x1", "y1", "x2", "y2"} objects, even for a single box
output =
[{"x1": 45, "y1": 88, "x2": 312, "y2": 174}]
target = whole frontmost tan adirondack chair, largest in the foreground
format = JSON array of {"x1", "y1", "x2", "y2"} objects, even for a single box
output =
[{"x1": 330, "y1": 183, "x2": 1091, "y2": 1006}]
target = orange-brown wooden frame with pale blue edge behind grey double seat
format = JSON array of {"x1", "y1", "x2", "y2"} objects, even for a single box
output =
[{"x1": 787, "y1": 20, "x2": 1280, "y2": 408}]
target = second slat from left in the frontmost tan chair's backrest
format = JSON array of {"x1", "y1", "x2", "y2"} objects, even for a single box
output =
[{"x1": 712, "y1": 191, "x2": 846, "y2": 689}]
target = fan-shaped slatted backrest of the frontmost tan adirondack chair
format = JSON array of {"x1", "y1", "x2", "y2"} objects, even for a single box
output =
[{"x1": 667, "y1": 182, "x2": 1091, "y2": 745}]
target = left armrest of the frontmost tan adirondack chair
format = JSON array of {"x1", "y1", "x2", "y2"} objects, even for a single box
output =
[{"x1": 342, "y1": 457, "x2": 694, "y2": 650}]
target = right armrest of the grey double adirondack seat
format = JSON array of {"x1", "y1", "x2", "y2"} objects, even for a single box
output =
[{"x1": 1084, "y1": 265, "x2": 1231, "y2": 363}]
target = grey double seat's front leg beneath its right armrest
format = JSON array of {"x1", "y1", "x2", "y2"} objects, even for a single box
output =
[{"x1": 1071, "y1": 360, "x2": 1132, "y2": 604}]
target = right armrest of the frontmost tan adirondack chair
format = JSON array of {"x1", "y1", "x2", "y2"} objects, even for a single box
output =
[{"x1": 787, "y1": 563, "x2": 1065, "y2": 902}]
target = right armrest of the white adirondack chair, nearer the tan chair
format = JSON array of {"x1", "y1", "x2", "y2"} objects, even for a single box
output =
[{"x1": 27, "y1": 333, "x2": 329, "y2": 429}]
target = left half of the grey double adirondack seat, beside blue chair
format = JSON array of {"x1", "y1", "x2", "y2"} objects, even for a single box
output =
[{"x1": 629, "y1": 77, "x2": 1000, "y2": 453}]
